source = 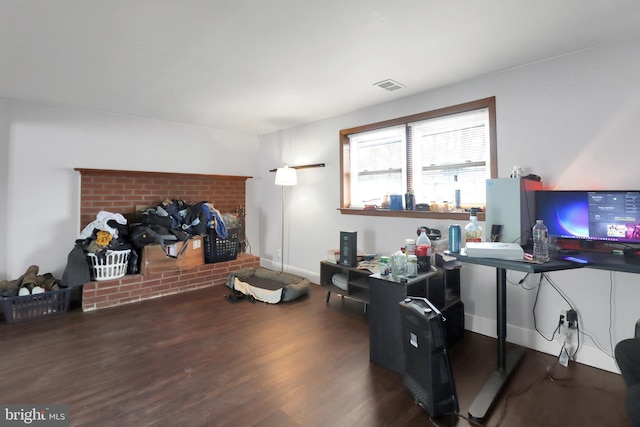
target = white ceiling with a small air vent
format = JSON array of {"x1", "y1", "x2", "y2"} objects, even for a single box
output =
[{"x1": 0, "y1": 0, "x2": 640, "y2": 134}]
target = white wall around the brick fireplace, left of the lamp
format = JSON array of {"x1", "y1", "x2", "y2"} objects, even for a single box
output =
[{"x1": 0, "y1": 100, "x2": 259, "y2": 280}]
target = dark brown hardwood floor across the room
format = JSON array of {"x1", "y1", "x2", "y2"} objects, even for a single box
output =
[{"x1": 0, "y1": 285, "x2": 629, "y2": 427}]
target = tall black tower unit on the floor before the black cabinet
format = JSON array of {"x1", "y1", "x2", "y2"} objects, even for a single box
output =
[{"x1": 400, "y1": 297, "x2": 460, "y2": 418}]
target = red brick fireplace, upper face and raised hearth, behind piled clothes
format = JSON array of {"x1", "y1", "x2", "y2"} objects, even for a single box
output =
[{"x1": 76, "y1": 168, "x2": 260, "y2": 311}]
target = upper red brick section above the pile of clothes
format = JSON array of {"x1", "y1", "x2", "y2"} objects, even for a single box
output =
[{"x1": 76, "y1": 169, "x2": 251, "y2": 229}]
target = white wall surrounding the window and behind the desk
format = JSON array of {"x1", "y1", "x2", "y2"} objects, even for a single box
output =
[{"x1": 259, "y1": 36, "x2": 640, "y2": 371}]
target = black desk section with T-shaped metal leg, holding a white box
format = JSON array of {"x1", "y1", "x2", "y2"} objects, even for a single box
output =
[{"x1": 451, "y1": 254, "x2": 585, "y2": 421}]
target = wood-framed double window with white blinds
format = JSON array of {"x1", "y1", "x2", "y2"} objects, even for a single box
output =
[{"x1": 340, "y1": 97, "x2": 497, "y2": 216}]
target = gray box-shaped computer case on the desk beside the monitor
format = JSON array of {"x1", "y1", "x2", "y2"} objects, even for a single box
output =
[{"x1": 484, "y1": 178, "x2": 542, "y2": 246}]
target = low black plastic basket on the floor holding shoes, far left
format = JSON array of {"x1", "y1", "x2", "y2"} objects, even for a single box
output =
[{"x1": 2, "y1": 288, "x2": 71, "y2": 323}]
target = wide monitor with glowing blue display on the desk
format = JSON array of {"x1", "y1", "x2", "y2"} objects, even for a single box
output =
[{"x1": 536, "y1": 191, "x2": 640, "y2": 243}]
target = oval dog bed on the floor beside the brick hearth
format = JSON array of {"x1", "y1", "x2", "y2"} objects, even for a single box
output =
[{"x1": 225, "y1": 267, "x2": 309, "y2": 304}]
